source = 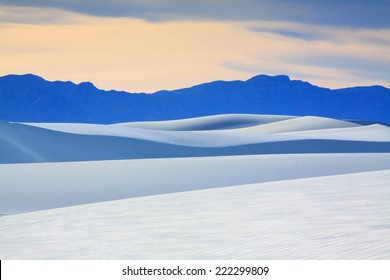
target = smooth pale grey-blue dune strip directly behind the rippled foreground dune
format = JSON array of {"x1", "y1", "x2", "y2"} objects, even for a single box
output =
[{"x1": 0, "y1": 153, "x2": 390, "y2": 214}]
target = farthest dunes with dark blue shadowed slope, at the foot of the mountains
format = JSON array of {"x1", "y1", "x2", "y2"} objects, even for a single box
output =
[{"x1": 0, "y1": 115, "x2": 390, "y2": 163}]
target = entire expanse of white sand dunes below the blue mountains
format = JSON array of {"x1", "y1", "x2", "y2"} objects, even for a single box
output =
[{"x1": 0, "y1": 115, "x2": 390, "y2": 259}]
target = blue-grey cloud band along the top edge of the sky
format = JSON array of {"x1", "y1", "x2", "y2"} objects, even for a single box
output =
[{"x1": 0, "y1": 0, "x2": 390, "y2": 28}]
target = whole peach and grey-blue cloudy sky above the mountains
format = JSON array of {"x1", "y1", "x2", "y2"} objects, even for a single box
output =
[{"x1": 0, "y1": 0, "x2": 390, "y2": 92}]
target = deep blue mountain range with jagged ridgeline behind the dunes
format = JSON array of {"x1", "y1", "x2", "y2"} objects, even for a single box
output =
[{"x1": 0, "y1": 74, "x2": 390, "y2": 124}]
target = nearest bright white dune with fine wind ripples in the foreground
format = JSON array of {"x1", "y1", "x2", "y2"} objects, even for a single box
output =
[{"x1": 0, "y1": 170, "x2": 390, "y2": 260}]
